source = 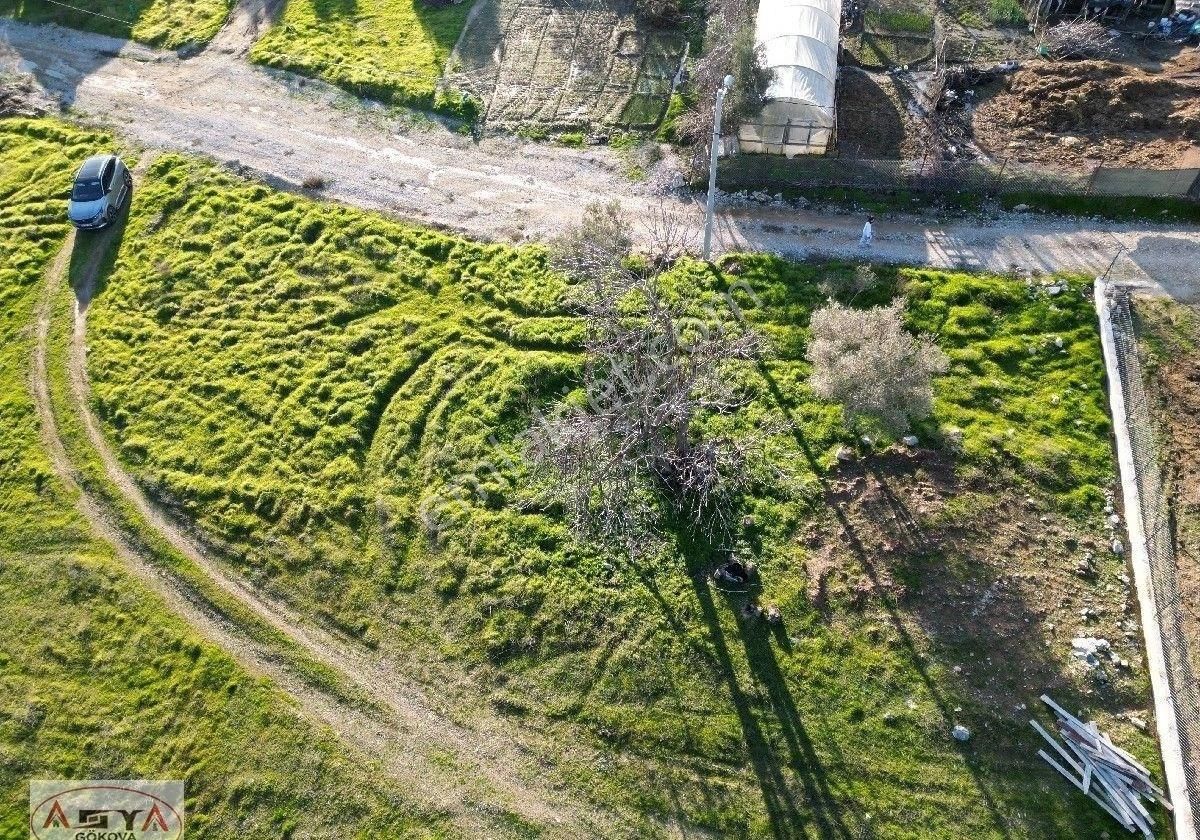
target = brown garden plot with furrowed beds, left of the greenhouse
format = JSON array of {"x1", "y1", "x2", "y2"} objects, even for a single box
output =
[{"x1": 446, "y1": 0, "x2": 684, "y2": 127}]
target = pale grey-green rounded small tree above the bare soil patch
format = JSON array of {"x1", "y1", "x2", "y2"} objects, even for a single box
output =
[{"x1": 808, "y1": 298, "x2": 949, "y2": 434}]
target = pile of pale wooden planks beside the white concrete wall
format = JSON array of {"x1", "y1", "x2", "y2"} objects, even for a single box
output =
[{"x1": 1030, "y1": 695, "x2": 1171, "y2": 838}]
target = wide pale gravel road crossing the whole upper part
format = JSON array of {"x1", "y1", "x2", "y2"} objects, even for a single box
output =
[{"x1": 0, "y1": 17, "x2": 1200, "y2": 300}]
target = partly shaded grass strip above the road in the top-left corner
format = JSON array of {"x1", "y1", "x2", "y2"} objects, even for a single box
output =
[{"x1": 0, "y1": 0, "x2": 233, "y2": 49}]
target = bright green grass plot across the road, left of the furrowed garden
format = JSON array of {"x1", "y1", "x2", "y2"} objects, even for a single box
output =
[{"x1": 250, "y1": 0, "x2": 470, "y2": 110}]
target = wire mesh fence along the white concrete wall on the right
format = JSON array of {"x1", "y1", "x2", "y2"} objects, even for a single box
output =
[{"x1": 1110, "y1": 288, "x2": 1200, "y2": 814}]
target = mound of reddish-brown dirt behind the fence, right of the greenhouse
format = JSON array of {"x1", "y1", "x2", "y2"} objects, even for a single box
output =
[{"x1": 972, "y1": 61, "x2": 1200, "y2": 169}]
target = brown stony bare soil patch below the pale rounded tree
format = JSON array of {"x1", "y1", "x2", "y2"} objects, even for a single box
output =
[{"x1": 803, "y1": 450, "x2": 1144, "y2": 725}]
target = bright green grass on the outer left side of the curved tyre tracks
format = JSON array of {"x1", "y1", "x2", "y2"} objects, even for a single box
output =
[{"x1": 0, "y1": 120, "x2": 458, "y2": 838}]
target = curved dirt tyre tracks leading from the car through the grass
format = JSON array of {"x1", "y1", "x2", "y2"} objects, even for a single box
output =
[{"x1": 30, "y1": 218, "x2": 608, "y2": 838}]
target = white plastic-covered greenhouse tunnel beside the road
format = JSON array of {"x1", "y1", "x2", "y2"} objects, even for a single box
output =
[{"x1": 738, "y1": 0, "x2": 841, "y2": 157}]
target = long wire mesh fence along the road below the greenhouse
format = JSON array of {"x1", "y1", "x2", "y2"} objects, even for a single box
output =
[{"x1": 720, "y1": 155, "x2": 1200, "y2": 198}]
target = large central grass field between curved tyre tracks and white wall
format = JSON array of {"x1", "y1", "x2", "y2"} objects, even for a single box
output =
[{"x1": 70, "y1": 141, "x2": 1156, "y2": 838}]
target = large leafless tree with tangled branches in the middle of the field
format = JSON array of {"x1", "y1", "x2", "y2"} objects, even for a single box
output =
[{"x1": 529, "y1": 205, "x2": 763, "y2": 551}]
